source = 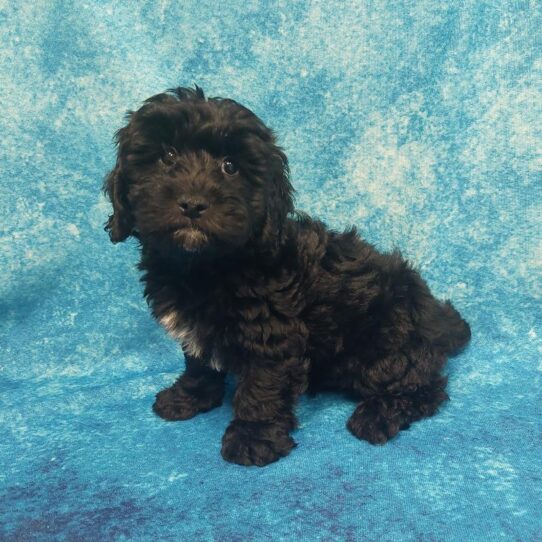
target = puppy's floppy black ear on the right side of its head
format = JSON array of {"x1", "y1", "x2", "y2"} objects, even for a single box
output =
[{"x1": 262, "y1": 143, "x2": 294, "y2": 245}]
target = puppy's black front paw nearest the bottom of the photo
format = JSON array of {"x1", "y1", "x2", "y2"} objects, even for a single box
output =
[{"x1": 221, "y1": 420, "x2": 296, "y2": 467}]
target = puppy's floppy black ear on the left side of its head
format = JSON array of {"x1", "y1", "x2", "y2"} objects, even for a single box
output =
[{"x1": 103, "y1": 127, "x2": 134, "y2": 243}]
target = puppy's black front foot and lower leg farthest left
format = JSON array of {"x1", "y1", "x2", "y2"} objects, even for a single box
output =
[{"x1": 152, "y1": 356, "x2": 226, "y2": 421}]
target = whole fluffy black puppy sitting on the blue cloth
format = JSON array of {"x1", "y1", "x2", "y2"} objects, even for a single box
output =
[{"x1": 104, "y1": 87, "x2": 470, "y2": 465}]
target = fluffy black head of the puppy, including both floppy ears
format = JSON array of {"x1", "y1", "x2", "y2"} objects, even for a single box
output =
[{"x1": 104, "y1": 87, "x2": 293, "y2": 252}]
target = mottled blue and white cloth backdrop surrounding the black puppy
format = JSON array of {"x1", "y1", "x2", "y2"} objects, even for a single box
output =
[{"x1": 0, "y1": 0, "x2": 542, "y2": 541}]
